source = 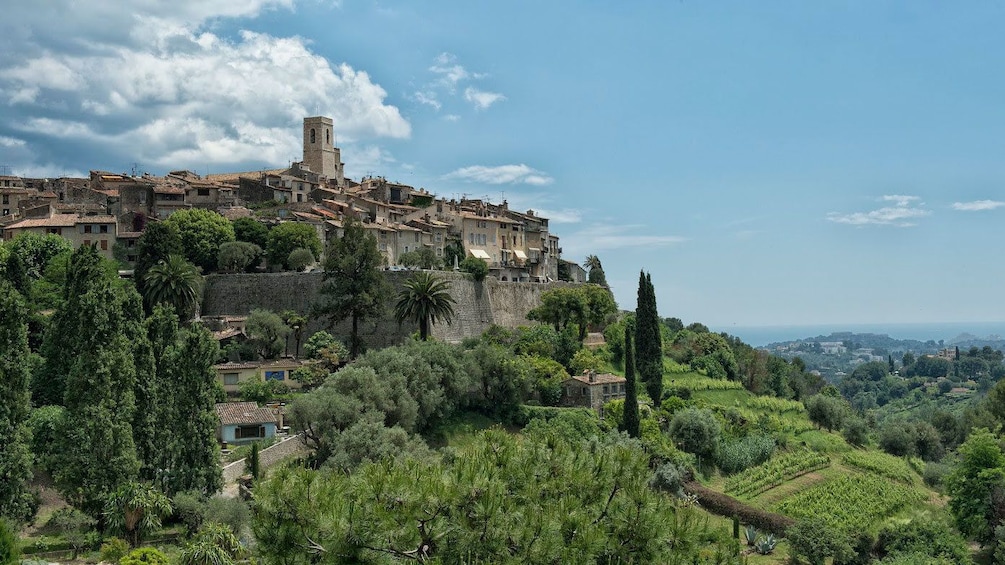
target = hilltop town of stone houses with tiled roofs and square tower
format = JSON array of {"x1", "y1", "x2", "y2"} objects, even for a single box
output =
[{"x1": 0, "y1": 117, "x2": 574, "y2": 283}]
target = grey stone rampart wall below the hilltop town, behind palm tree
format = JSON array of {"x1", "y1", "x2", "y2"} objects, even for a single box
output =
[{"x1": 202, "y1": 271, "x2": 569, "y2": 347}]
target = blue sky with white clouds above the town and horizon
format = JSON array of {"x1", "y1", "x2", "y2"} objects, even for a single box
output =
[{"x1": 0, "y1": 0, "x2": 1005, "y2": 330}]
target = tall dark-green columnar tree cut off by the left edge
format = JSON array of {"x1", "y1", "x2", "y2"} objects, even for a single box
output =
[{"x1": 0, "y1": 279, "x2": 37, "y2": 524}]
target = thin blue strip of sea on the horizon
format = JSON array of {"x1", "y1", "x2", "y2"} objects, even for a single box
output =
[{"x1": 710, "y1": 322, "x2": 1005, "y2": 347}]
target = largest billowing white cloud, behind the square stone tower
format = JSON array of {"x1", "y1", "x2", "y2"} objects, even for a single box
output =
[{"x1": 0, "y1": 0, "x2": 411, "y2": 170}]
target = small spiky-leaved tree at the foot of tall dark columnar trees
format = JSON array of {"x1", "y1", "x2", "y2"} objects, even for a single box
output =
[{"x1": 104, "y1": 483, "x2": 171, "y2": 547}]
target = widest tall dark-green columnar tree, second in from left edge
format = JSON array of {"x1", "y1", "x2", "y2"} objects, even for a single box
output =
[{"x1": 46, "y1": 246, "x2": 143, "y2": 516}]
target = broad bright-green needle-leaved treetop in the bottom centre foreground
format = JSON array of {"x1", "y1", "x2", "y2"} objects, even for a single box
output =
[{"x1": 253, "y1": 430, "x2": 705, "y2": 565}]
